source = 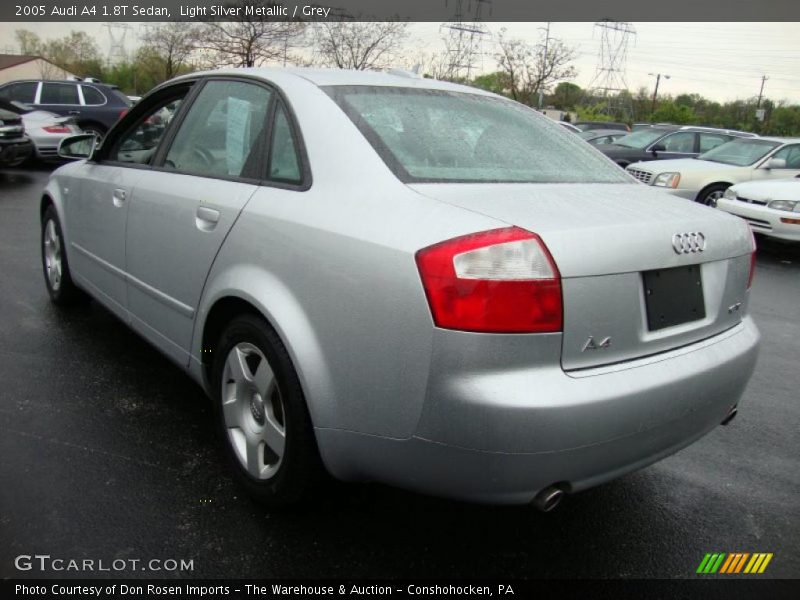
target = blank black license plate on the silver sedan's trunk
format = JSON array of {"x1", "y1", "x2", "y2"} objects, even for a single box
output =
[{"x1": 642, "y1": 265, "x2": 706, "y2": 331}]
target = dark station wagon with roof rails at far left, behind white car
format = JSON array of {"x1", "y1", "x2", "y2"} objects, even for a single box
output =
[{"x1": 0, "y1": 80, "x2": 131, "y2": 137}]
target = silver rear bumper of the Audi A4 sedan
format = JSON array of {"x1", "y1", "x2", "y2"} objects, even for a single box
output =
[{"x1": 317, "y1": 318, "x2": 759, "y2": 504}]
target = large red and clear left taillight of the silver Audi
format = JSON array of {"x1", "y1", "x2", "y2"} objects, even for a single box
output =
[{"x1": 416, "y1": 227, "x2": 563, "y2": 333}]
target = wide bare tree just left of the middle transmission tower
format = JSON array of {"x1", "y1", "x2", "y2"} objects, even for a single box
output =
[{"x1": 313, "y1": 21, "x2": 408, "y2": 70}]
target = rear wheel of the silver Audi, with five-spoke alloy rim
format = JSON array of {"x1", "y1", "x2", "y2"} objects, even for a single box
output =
[{"x1": 212, "y1": 315, "x2": 323, "y2": 506}]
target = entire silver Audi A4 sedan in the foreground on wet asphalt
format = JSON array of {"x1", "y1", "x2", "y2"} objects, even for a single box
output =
[{"x1": 41, "y1": 69, "x2": 759, "y2": 508}]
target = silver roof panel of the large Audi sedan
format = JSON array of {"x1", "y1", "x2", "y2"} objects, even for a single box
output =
[{"x1": 173, "y1": 67, "x2": 496, "y2": 96}]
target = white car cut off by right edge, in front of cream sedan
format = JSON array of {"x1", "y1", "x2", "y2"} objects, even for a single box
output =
[{"x1": 717, "y1": 178, "x2": 800, "y2": 242}]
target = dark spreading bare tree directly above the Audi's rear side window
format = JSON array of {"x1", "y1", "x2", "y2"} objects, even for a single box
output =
[{"x1": 196, "y1": 0, "x2": 305, "y2": 67}]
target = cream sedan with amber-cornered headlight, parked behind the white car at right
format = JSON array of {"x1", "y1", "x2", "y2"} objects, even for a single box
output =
[{"x1": 626, "y1": 137, "x2": 800, "y2": 206}]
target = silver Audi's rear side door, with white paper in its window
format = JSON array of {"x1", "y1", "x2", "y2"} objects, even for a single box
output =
[{"x1": 126, "y1": 79, "x2": 273, "y2": 364}]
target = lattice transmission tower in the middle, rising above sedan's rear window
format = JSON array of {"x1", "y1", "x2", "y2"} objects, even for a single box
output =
[{"x1": 439, "y1": 0, "x2": 492, "y2": 79}]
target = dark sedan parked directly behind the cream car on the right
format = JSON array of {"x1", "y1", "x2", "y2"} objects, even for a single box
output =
[{"x1": 597, "y1": 125, "x2": 757, "y2": 167}]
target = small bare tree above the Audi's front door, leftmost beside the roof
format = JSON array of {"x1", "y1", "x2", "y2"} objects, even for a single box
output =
[{"x1": 137, "y1": 21, "x2": 197, "y2": 82}]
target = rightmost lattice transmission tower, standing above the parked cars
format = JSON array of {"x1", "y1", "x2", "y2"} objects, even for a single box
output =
[{"x1": 587, "y1": 19, "x2": 636, "y2": 120}]
